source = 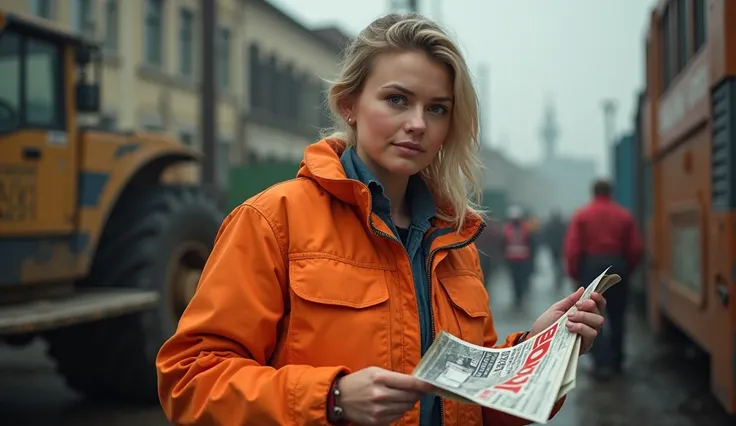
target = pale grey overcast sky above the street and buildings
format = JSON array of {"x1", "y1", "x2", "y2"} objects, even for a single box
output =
[{"x1": 271, "y1": 0, "x2": 656, "y2": 174}]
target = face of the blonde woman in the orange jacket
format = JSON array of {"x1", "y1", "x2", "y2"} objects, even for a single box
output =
[{"x1": 344, "y1": 51, "x2": 453, "y2": 181}]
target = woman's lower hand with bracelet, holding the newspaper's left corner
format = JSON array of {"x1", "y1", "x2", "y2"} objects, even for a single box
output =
[{"x1": 338, "y1": 367, "x2": 434, "y2": 426}]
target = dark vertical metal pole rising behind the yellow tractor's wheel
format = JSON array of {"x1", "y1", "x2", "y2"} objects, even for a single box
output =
[{"x1": 200, "y1": 0, "x2": 220, "y2": 202}]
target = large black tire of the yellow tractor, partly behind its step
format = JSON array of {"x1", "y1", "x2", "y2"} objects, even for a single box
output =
[{"x1": 46, "y1": 187, "x2": 224, "y2": 403}]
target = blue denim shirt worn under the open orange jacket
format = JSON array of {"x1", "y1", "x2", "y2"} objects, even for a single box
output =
[{"x1": 340, "y1": 148, "x2": 442, "y2": 426}]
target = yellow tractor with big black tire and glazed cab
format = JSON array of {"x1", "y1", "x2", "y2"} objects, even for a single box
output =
[{"x1": 0, "y1": 11, "x2": 223, "y2": 401}]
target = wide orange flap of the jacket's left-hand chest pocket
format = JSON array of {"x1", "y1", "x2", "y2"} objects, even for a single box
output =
[{"x1": 289, "y1": 258, "x2": 388, "y2": 309}]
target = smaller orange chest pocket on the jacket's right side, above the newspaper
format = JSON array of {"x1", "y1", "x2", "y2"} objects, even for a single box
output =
[{"x1": 439, "y1": 274, "x2": 490, "y2": 346}]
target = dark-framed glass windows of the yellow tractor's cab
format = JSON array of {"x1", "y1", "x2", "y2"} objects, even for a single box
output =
[{"x1": 0, "y1": 31, "x2": 64, "y2": 133}]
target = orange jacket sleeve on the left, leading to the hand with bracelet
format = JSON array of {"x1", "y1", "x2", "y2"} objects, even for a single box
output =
[{"x1": 156, "y1": 205, "x2": 348, "y2": 426}]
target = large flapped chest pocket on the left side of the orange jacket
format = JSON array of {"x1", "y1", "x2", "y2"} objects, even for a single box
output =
[{"x1": 286, "y1": 258, "x2": 390, "y2": 369}]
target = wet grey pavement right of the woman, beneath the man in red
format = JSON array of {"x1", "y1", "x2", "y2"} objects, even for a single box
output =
[{"x1": 489, "y1": 253, "x2": 736, "y2": 426}]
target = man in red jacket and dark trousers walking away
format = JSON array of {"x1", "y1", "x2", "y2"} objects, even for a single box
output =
[{"x1": 564, "y1": 180, "x2": 644, "y2": 377}]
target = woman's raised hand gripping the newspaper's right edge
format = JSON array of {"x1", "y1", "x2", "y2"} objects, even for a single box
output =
[{"x1": 527, "y1": 287, "x2": 606, "y2": 355}]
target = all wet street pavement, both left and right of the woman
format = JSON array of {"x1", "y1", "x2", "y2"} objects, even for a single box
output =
[{"x1": 0, "y1": 248, "x2": 736, "y2": 426}]
